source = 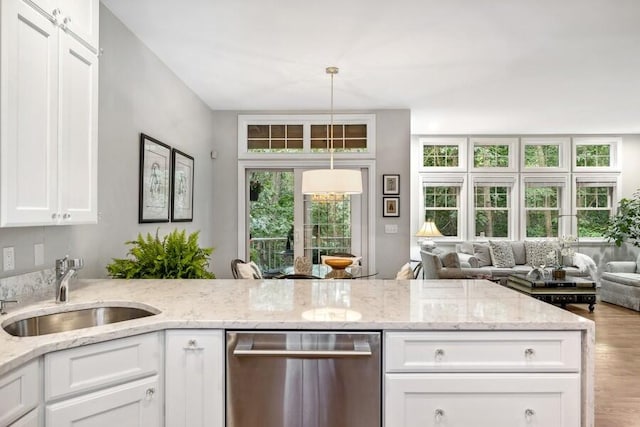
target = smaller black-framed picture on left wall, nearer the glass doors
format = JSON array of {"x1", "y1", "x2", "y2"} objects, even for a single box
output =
[{"x1": 171, "y1": 148, "x2": 193, "y2": 222}]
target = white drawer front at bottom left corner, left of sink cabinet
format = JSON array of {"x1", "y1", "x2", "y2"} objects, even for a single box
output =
[{"x1": 0, "y1": 359, "x2": 42, "y2": 426}]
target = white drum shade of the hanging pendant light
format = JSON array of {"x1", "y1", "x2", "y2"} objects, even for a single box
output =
[{"x1": 302, "y1": 169, "x2": 362, "y2": 194}]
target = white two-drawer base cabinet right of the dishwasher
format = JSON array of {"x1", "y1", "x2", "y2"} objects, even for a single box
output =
[{"x1": 384, "y1": 331, "x2": 582, "y2": 427}]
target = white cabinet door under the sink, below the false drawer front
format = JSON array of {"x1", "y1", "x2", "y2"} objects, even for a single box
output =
[{"x1": 45, "y1": 376, "x2": 162, "y2": 427}]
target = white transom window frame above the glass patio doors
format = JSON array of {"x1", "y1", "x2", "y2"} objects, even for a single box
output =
[{"x1": 238, "y1": 114, "x2": 376, "y2": 162}]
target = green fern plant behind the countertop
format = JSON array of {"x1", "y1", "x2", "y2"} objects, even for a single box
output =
[{"x1": 107, "y1": 230, "x2": 216, "y2": 279}]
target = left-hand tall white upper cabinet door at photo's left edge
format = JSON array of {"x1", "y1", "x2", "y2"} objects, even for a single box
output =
[{"x1": 0, "y1": 0, "x2": 59, "y2": 226}]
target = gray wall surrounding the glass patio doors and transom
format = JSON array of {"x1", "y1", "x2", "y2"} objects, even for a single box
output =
[{"x1": 212, "y1": 110, "x2": 411, "y2": 278}]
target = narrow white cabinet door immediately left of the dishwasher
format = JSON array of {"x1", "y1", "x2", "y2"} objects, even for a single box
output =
[{"x1": 165, "y1": 330, "x2": 224, "y2": 427}]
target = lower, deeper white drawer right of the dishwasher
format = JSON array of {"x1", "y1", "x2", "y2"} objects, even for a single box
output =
[{"x1": 385, "y1": 373, "x2": 581, "y2": 427}]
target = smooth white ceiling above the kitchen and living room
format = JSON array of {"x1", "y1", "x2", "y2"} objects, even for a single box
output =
[{"x1": 102, "y1": 0, "x2": 640, "y2": 134}]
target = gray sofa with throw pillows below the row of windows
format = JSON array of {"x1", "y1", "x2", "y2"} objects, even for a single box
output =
[{"x1": 420, "y1": 241, "x2": 596, "y2": 280}]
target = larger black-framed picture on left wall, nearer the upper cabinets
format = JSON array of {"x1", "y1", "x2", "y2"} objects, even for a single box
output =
[{"x1": 138, "y1": 133, "x2": 171, "y2": 223}]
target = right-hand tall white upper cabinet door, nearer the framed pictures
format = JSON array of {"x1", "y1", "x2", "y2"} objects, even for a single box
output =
[{"x1": 58, "y1": 33, "x2": 98, "y2": 224}]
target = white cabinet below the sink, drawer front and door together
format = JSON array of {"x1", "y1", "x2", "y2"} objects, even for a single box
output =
[{"x1": 44, "y1": 332, "x2": 164, "y2": 427}]
